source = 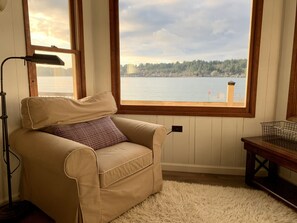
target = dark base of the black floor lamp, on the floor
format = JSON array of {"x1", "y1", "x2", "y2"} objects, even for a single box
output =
[{"x1": 0, "y1": 201, "x2": 33, "y2": 223}]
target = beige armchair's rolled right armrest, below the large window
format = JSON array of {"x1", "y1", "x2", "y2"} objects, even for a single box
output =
[{"x1": 112, "y1": 116, "x2": 166, "y2": 149}]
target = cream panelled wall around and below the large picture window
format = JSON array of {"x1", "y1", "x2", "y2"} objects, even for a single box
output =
[{"x1": 93, "y1": 0, "x2": 286, "y2": 174}]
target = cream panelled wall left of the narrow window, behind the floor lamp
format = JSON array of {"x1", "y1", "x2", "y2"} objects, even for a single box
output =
[{"x1": 0, "y1": 1, "x2": 29, "y2": 204}]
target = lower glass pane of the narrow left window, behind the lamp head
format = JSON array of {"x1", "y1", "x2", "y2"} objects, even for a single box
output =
[{"x1": 36, "y1": 52, "x2": 75, "y2": 98}]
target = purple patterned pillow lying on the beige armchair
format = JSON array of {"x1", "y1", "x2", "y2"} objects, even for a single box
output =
[{"x1": 42, "y1": 116, "x2": 128, "y2": 150}]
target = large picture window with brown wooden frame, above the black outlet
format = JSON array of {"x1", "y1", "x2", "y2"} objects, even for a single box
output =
[{"x1": 109, "y1": 0, "x2": 264, "y2": 117}]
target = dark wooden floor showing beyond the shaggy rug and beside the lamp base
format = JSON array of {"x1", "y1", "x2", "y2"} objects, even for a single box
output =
[{"x1": 1, "y1": 171, "x2": 248, "y2": 223}]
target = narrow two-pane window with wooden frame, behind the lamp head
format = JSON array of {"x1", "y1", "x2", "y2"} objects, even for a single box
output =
[{"x1": 23, "y1": 0, "x2": 86, "y2": 98}]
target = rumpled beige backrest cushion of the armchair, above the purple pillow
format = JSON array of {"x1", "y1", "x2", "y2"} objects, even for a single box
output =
[{"x1": 21, "y1": 92, "x2": 117, "y2": 129}]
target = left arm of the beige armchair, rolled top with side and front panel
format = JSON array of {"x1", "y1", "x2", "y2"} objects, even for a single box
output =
[{"x1": 10, "y1": 129, "x2": 100, "y2": 222}]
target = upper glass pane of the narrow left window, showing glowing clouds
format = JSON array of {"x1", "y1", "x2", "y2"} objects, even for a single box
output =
[{"x1": 28, "y1": 0, "x2": 71, "y2": 49}]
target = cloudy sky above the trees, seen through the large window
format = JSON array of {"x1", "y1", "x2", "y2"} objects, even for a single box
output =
[{"x1": 119, "y1": 0, "x2": 251, "y2": 65}]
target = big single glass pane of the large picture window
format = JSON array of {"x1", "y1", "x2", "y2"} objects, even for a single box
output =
[{"x1": 119, "y1": 0, "x2": 251, "y2": 107}]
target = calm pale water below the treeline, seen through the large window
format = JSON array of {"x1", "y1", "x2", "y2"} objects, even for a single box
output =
[{"x1": 121, "y1": 77, "x2": 246, "y2": 102}]
